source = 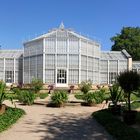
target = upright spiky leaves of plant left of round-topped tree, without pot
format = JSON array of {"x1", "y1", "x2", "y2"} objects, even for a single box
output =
[{"x1": 109, "y1": 84, "x2": 122, "y2": 106}]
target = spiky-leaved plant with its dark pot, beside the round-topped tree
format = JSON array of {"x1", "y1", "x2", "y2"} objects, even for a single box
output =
[{"x1": 109, "y1": 84, "x2": 122, "y2": 115}]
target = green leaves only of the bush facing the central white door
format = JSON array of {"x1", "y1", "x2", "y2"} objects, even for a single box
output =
[{"x1": 51, "y1": 90, "x2": 68, "y2": 104}]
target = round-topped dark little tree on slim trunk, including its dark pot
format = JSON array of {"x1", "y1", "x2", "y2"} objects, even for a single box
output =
[{"x1": 117, "y1": 71, "x2": 140, "y2": 125}]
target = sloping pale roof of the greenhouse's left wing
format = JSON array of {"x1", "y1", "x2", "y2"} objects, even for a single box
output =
[{"x1": 0, "y1": 50, "x2": 23, "y2": 58}]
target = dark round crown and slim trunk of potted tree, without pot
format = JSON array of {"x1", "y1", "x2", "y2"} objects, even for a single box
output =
[{"x1": 118, "y1": 71, "x2": 140, "y2": 112}]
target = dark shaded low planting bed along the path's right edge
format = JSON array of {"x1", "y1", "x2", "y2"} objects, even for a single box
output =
[{"x1": 92, "y1": 109, "x2": 140, "y2": 140}]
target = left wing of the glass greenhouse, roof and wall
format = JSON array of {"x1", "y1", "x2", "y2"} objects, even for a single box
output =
[{"x1": 0, "y1": 50, "x2": 23, "y2": 84}]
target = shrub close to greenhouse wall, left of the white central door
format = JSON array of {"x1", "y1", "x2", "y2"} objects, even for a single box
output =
[{"x1": 31, "y1": 79, "x2": 43, "y2": 93}]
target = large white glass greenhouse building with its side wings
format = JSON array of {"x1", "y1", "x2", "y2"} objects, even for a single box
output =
[{"x1": 0, "y1": 24, "x2": 132, "y2": 87}]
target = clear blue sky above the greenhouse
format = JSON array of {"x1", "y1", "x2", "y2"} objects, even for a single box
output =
[{"x1": 0, "y1": 0, "x2": 140, "y2": 50}]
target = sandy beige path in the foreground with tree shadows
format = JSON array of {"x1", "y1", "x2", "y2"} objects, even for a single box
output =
[{"x1": 0, "y1": 97, "x2": 111, "y2": 140}]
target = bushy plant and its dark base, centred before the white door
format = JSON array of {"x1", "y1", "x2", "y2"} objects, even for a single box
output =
[{"x1": 48, "y1": 90, "x2": 68, "y2": 107}]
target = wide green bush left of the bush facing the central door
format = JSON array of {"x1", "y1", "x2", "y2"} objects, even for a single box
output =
[{"x1": 18, "y1": 90, "x2": 35, "y2": 105}]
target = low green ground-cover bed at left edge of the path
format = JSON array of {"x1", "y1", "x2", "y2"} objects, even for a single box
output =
[{"x1": 0, "y1": 107, "x2": 25, "y2": 132}]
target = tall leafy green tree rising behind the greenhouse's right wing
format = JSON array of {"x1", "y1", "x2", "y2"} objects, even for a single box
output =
[{"x1": 111, "y1": 27, "x2": 140, "y2": 60}]
